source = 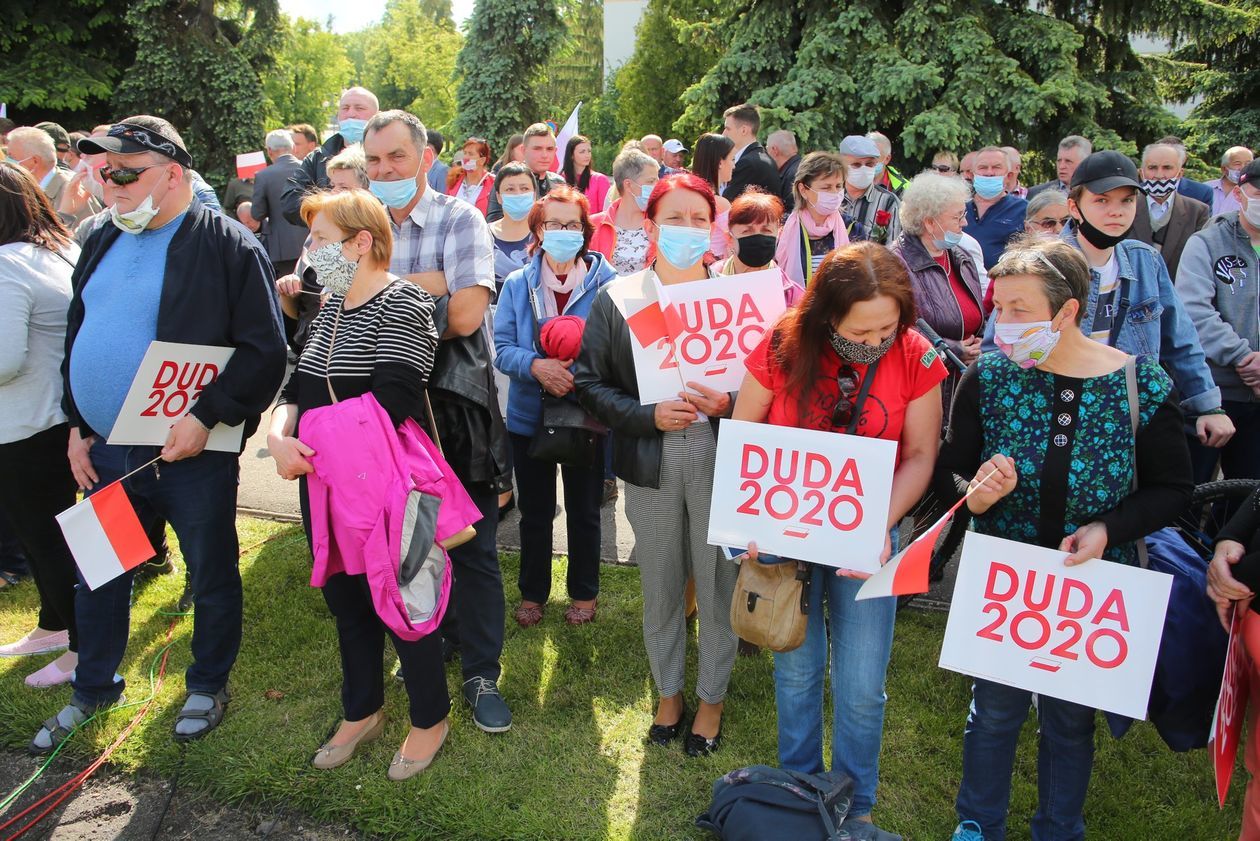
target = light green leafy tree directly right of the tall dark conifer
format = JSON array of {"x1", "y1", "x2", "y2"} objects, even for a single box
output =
[{"x1": 262, "y1": 18, "x2": 354, "y2": 127}]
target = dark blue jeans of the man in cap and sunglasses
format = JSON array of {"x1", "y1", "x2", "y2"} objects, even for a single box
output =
[{"x1": 74, "y1": 439, "x2": 242, "y2": 709}]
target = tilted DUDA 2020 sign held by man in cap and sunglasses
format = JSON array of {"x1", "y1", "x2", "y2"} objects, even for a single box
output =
[{"x1": 108, "y1": 342, "x2": 244, "y2": 453}]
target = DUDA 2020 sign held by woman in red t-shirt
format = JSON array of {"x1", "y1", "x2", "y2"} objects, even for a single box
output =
[{"x1": 708, "y1": 421, "x2": 897, "y2": 572}]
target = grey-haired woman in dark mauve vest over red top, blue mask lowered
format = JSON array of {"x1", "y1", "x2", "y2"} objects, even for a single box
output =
[{"x1": 890, "y1": 173, "x2": 984, "y2": 417}]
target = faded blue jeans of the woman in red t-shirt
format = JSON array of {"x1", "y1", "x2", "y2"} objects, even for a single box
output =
[{"x1": 775, "y1": 552, "x2": 897, "y2": 817}]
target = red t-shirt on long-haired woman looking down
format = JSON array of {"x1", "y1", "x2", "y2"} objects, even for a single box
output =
[{"x1": 745, "y1": 328, "x2": 948, "y2": 453}]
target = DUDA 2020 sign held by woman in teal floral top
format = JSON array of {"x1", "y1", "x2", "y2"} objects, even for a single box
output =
[{"x1": 940, "y1": 532, "x2": 1172, "y2": 719}]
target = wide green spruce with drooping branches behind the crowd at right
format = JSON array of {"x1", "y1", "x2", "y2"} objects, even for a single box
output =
[{"x1": 674, "y1": 0, "x2": 1184, "y2": 171}]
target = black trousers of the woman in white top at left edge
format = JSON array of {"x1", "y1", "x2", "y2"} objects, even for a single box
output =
[{"x1": 0, "y1": 424, "x2": 78, "y2": 651}]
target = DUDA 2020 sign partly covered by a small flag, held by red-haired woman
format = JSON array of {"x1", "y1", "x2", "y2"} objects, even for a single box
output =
[{"x1": 619, "y1": 269, "x2": 786, "y2": 406}]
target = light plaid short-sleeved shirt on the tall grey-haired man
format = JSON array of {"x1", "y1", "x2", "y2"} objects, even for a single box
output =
[{"x1": 389, "y1": 188, "x2": 494, "y2": 295}]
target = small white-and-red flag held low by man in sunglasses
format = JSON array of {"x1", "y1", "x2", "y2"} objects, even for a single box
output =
[{"x1": 57, "y1": 480, "x2": 158, "y2": 590}]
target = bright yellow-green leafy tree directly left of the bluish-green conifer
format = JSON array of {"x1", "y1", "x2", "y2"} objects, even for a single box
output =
[{"x1": 350, "y1": 0, "x2": 464, "y2": 129}]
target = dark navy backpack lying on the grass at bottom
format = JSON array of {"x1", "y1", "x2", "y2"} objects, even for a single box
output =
[{"x1": 696, "y1": 765, "x2": 853, "y2": 841}]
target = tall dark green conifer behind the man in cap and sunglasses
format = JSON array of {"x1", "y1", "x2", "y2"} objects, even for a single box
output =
[{"x1": 112, "y1": 0, "x2": 280, "y2": 187}]
